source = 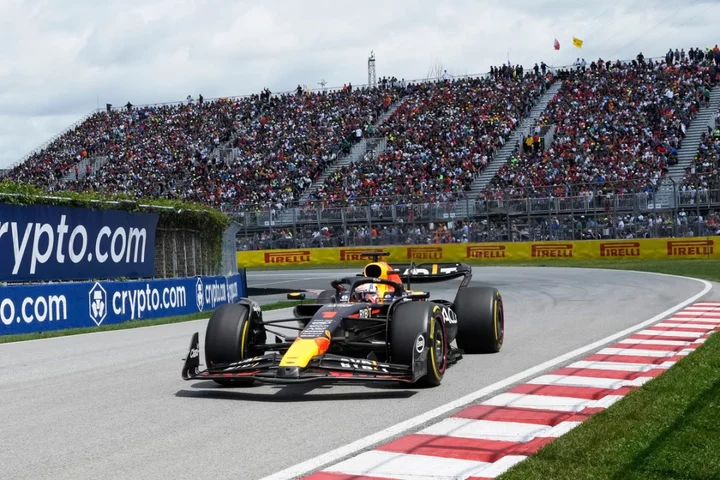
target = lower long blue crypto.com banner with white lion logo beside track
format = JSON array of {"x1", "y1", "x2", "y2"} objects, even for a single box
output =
[{"x1": 0, "y1": 274, "x2": 247, "y2": 335}]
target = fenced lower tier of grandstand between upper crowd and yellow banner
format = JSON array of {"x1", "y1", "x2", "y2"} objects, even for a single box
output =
[{"x1": 233, "y1": 179, "x2": 720, "y2": 250}]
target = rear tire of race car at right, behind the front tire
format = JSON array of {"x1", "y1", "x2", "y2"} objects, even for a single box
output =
[{"x1": 454, "y1": 287, "x2": 505, "y2": 353}]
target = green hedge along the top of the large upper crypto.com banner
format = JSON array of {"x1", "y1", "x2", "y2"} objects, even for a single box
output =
[{"x1": 0, "y1": 179, "x2": 231, "y2": 270}]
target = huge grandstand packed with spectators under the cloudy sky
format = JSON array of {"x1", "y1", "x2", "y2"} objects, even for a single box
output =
[{"x1": 6, "y1": 44, "x2": 720, "y2": 248}]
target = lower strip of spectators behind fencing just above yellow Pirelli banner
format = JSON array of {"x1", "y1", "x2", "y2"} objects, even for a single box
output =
[{"x1": 238, "y1": 209, "x2": 720, "y2": 250}]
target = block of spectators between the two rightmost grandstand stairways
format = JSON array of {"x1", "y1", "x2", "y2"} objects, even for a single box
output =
[{"x1": 481, "y1": 55, "x2": 718, "y2": 199}]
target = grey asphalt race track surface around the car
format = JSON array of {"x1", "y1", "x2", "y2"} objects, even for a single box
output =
[{"x1": 0, "y1": 267, "x2": 717, "y2": 480}]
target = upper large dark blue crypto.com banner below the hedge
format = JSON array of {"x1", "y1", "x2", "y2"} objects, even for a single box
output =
[{"x1": 0, "y1": 204, "x2": 158, "y2": 282}]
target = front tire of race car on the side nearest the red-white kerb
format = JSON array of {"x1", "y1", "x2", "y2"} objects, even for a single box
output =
[{"x1": 389, "y1": 302, "x2": 448, "y2": 387}]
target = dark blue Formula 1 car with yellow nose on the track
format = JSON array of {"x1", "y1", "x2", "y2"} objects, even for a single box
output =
[{"x1": 182, "y1": 252, "x2": 505, "y2": 386}]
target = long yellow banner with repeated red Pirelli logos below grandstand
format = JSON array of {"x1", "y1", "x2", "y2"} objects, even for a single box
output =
[{"x1": 237, "y1": 237, "x2": 720, "y2": 268}]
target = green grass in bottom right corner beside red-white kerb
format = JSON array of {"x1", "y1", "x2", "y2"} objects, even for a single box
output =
[{"x1": 499, "y1": 326, "x2": 720, "y2": 480}]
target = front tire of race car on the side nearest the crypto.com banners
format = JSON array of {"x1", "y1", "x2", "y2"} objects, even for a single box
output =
[{"x1": 205, "y1": 304, "x2": 254, "y2": 386}]
